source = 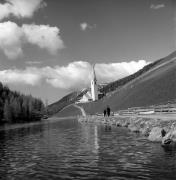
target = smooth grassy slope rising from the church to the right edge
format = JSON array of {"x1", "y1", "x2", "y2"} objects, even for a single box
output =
[{"x1": 82, "y1": 52, "x2": 176, "y2": 114}]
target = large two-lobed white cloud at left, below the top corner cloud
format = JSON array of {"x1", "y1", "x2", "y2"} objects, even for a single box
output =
[{"x1": 0, "y1": 21, "x2": 64, "y2": 59}]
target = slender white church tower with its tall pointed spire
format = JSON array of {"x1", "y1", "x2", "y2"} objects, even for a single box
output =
[{"x1": 91, "y1": 64, "x2": 98, "y2": 101}]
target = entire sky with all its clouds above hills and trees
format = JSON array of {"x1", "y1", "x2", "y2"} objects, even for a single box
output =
[{"x1": 0, "y1": 0, "x2": 176, "y2": 103}]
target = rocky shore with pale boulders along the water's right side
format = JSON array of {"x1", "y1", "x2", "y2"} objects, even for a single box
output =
[{"x1": 79, "y1": 115, "x2": 176, "y2": 147}]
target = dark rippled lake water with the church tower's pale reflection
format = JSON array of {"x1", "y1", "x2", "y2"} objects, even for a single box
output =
[{"x1": 0, "y1": 119, "x2": 176, "y2": 180}]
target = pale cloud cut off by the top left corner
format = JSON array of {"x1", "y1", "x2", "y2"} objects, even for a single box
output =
[{"x1": 0, "y1": 0, "x2": 46, "y2": 20}]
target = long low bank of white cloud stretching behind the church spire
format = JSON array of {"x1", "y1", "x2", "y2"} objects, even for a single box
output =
[{"x1": 0, "y1": 60, "x2": 148, "y2": 90}]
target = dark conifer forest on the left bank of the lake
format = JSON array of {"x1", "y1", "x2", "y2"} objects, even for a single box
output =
[{"x1": 0, "y1": 82, "x2": 44, "y2": 123}]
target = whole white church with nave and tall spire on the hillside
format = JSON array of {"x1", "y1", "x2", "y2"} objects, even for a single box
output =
[{"x1": 76, "y1": 64, "x2": 102, "y2": 103}]
